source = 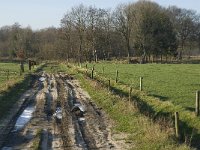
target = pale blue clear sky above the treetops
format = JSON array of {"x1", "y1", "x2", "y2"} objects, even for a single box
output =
[{"x1": 0, "y1": 0, "x2": 200, "y2": 30}]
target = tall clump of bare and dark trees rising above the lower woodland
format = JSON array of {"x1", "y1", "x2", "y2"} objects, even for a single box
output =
[{"x1": 61, "y1": 1, "x2": 178, "y2": 62}]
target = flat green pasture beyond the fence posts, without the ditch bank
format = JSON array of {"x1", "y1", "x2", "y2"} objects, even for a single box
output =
[{"x1": 85, "y1": 63, "x2": 200, "y2": 111}]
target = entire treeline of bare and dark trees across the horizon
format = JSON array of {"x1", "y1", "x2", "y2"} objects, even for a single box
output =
[{"x1": 0, "y1": 1, "x2": 200, "y2": 63}]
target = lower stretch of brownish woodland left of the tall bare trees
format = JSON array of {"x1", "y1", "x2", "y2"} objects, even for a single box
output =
[{"x1": 0, "y1": 23, "x2": 57, "y2": 59}]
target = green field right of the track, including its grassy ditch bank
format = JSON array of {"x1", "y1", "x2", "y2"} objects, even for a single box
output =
[{"x1": 75, "y1": 63, "x2": 200, "y2": 148}]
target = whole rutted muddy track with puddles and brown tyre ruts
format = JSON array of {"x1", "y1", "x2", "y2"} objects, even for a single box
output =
[{"x1": 0, "y1": 73, "x2": 125, "y2": 150}]
